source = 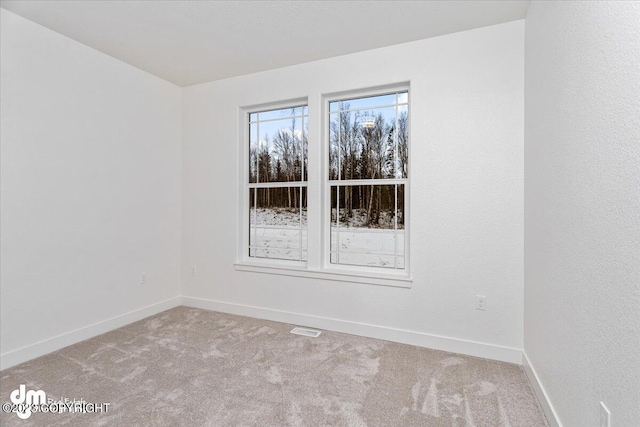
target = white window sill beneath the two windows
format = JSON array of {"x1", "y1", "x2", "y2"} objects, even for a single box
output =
[{"x1": 234, "y1": 262, "x2": 413, "y2": 288}]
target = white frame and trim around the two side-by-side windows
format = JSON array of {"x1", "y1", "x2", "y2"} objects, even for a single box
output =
[{"x1": 234, "y1": 83, "x2": 413, "y2": 288}]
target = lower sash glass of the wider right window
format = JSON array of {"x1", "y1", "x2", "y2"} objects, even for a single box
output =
[{"x1": 330, "y1": 184, "x2": 404, "y2": 268}]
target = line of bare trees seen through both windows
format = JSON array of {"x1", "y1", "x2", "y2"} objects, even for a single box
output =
[{"x1": 249, "y1": 105, "x2": 409, "y2": 226}]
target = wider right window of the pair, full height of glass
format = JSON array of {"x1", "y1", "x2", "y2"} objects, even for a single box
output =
[{"x1": 328, "y1": 91, "x2": 409, "y2": 269}]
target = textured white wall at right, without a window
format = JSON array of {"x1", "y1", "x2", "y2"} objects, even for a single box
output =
[{"x1": 524, "y1": 2, "x2": 640, "y2": 426}]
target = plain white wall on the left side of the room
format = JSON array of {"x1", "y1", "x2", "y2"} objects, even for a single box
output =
[{"x1": 0, "y1": 9, "x2": 181, "y2": 367}]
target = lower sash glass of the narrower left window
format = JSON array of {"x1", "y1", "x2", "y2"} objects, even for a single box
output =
[{"x1": 249, "y1": 187, "x2": 307, "y2": 260}]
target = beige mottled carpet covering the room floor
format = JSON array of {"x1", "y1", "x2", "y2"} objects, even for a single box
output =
[{"x1": 0, "y1": 307, "x2": 547, "y2": 427}]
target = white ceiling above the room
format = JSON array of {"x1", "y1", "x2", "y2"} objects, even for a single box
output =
[{"x1": 0, "y1": 0, "x2": 529, "y2": 86}]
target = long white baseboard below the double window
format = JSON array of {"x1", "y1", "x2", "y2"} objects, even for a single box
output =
[{"x1": 182, "y1": 296, "x2": 522, "y2": 365}]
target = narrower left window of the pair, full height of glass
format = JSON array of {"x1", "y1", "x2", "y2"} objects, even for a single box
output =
[{"x1": 248, "y1": 105, "x2": 308, "y2": 261}]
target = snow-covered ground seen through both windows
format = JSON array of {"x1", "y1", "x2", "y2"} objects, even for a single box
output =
[{"x1": 250, "y1": 209, "x2": 404, "y2": 268}]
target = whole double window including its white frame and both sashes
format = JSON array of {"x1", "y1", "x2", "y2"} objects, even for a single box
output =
[{"x1": 236, "y1": 85, "x2": 411, "y2": 287}]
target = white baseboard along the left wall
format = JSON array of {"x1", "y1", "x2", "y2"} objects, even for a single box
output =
[{"x1": 0, "y1": 297, "x2": 180, "y2": 370}]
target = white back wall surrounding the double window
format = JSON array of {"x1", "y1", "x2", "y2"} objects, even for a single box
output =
[{"x1": 182, "y1": 21, "x2": 524, "y2": 361}]
